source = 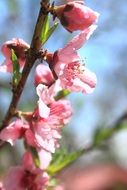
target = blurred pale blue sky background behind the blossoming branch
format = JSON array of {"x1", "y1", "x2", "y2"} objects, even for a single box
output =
[{"x1": 0, "y1": 0, "x2": 127, "y2": 189}]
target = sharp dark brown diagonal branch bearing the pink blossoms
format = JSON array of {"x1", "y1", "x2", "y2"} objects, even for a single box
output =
[{"x1": 0, "y1": 0, "x2": 48, "y2": 131}]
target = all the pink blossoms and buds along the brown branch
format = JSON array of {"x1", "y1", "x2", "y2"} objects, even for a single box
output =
[{"x1": 0, "y1": 1, "x2": 98, "y2": 190}]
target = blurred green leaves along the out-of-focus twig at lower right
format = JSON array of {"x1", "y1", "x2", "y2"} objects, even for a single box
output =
[{"x1": 47, "y1": 123, "x2": 127, "y2": 176}]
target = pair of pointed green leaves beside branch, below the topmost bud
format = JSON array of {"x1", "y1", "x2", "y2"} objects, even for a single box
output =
[{"x1": 40, "y1": 15, "x2": 59, "y2": 44}]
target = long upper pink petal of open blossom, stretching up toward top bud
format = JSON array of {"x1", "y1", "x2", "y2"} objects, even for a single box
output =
[{"x1": 53, "y1": 25, "x2": 97, "y2": 76}]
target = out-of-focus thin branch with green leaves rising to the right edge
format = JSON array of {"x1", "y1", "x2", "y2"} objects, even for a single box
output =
[{"x1": 47, "y1": 112, "x2": 127, "y2": 175}]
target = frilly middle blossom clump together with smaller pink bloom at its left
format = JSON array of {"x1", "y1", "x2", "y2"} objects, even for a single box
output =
[{"x1": 0, "y1": 83, "x2": 72, "y2": 168}]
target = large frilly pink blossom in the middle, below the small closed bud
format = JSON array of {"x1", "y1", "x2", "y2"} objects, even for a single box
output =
[{"x1": 31, "y1": 84, "x2": 72, "y2": 168}]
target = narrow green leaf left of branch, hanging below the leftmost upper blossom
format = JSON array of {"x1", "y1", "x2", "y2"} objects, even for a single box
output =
[{"x1": 11, "y1": 49, "x2": 21, "y2": 87}]
